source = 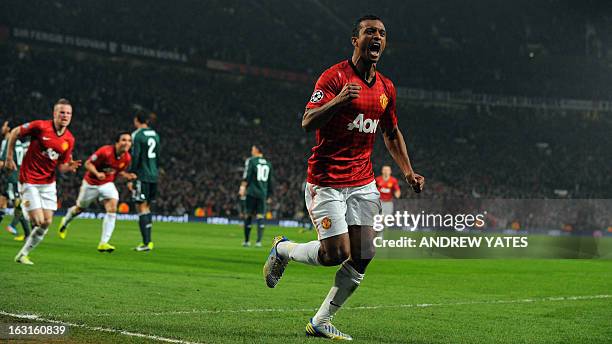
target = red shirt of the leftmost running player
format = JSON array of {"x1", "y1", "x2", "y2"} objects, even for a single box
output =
[{"x1": 19, "y1": 120, "x2": 74, "y2": 184}]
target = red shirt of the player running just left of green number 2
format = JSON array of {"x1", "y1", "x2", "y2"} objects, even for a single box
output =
[{"x1": 85, "y1": 145, "x2": 132, "y2": 185}]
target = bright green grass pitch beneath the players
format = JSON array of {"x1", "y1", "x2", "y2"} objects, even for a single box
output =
[{"x1": 0, "y1": 218, "x2": 612, "y2": 343}]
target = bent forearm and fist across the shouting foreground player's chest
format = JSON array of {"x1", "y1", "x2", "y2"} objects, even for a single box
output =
[{"x1": 302, "y1": 82, "x2": 361, "y2": 132}]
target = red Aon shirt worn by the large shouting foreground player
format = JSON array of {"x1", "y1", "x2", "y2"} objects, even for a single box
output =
[{"x1": 306, "y1": 60, "x2": 397, "y2": 188}]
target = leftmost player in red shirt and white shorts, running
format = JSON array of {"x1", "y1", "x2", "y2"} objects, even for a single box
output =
[{"x1": 5, "y1": 99, "x2": 81, "y2": 265}]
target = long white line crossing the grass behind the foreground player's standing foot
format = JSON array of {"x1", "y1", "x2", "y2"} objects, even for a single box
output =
[{"x1": 40, "y1": 295, "x2": 612, "y2": 317}]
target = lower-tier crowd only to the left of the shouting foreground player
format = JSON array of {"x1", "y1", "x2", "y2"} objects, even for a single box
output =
[{"x1": 0, "y1": 47, "x2": 308, "y2": 217}]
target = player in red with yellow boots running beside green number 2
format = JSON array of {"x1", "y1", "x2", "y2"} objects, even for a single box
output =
[{"x1": 59, "y1": 131, "x2": 136, "y2": 253}]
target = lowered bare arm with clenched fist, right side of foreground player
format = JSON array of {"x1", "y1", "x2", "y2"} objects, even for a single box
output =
[{"x1": 383, "y1": 126, "x2": 425, "y2": 193}]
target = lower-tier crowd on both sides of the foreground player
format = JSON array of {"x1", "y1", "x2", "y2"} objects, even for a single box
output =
[{"x1": 0, "y1": 45, "x2": 612, "y2": 218}]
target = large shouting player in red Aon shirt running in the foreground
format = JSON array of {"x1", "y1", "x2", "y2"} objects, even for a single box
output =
[{"x1": 264, "y1": 15, "x2": 425, "y2": 340}]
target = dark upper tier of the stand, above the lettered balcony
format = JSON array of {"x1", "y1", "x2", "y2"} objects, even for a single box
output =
[{"x1": 0, "y1": 0, "x2": 612, "y2": 99}]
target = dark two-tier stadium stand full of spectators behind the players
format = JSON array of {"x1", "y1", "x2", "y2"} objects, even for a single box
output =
[{"x1": 0, "y1": 0, "x2": 612, "y2": 218}]
